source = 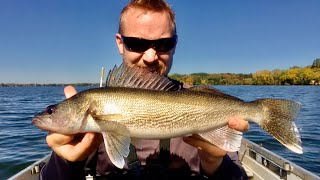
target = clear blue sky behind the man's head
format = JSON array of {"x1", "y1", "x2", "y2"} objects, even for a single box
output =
[{"x1": 0, "y1": 0, "x2": 320, "y2": 83}]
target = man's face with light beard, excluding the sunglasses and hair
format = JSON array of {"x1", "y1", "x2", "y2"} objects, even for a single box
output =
[{"x1": 116, "y1": 9, "x2": 175, "y2": 75}]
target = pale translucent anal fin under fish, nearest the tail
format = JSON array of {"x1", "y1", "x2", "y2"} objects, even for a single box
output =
[{"x1": 199, "y1": 126, "x2": 242, "y2": 152}]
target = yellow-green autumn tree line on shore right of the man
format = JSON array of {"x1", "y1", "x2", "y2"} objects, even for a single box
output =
[{"x1": 169, "y1": 58, "x2": 320, "y2": 85}]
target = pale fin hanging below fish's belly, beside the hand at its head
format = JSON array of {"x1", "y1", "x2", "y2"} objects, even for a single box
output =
[{"x1": 102, "y1": 132, "x2": 130, "y2": 169}]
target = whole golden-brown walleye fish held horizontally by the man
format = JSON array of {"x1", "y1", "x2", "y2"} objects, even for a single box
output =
[{"x1": 32, "y1": 64, "x2": 302, "y2": 168}]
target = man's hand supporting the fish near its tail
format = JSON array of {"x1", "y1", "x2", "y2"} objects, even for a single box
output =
[{"x1": 184, "y1": 118, "x2": 249, "y2": 175}]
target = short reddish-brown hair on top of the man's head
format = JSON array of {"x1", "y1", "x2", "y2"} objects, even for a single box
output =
[{"x1": 118, "y1": 0, "x2": 177, "y2": 35}]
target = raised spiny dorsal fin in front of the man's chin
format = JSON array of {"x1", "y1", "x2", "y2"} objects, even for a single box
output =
[{"x1": 106, "y1": 63, "x2": 180, "y2": 91}]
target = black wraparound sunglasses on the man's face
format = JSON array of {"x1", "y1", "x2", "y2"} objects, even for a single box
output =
[{"x1": 121, "y1": 35, "x2": 178, "y2": 52}]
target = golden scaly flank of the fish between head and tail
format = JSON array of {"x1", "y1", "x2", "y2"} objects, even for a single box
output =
[{"x1": 65, "y1": 87, "x2": 260, "y2": 138}]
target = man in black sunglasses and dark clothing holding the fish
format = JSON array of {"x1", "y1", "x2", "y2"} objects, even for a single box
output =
[{"x1": 41, "y1": 0, "x2": 249, "y2": 179}]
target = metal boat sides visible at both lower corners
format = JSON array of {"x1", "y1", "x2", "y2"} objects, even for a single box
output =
[{"x1": 9, "y1": 138, "x2": 320, "y2": 180}]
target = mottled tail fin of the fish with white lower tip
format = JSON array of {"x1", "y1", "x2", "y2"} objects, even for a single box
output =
[{"x1": 254, "y1": 99, "x2": 303, "y2": 154}]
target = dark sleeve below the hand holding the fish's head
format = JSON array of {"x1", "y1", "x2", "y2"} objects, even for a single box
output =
[{"x1": 40, "y1": 152, "x2": 86, "y2": 180}]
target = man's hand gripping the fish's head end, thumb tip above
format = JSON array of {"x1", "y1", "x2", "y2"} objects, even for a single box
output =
[{"x1": 46, "y1": 86, "x2": 102, "y2": 162}]
